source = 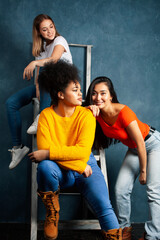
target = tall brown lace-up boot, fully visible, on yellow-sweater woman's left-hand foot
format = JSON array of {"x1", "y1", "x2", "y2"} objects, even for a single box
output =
[{"x1": 38, "y1": 190, "x2": 60, "y2": 240}]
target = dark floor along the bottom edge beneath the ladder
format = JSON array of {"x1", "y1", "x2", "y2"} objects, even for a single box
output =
[{"x1": 0, "y1": 223, "x2": 144, "y2": 240}]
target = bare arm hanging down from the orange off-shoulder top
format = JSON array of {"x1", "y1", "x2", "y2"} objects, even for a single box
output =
[{"x1": 126, "y1": 120, "x2": 147, "y2": 184}]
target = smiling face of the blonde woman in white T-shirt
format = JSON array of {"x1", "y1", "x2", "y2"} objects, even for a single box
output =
[{"x1": 39, "y1": 19, "x2": 56, "y2": 43}]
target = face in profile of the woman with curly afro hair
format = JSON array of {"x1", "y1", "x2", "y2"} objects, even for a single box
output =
[{"x1": 58, "y1": 82, "x2": 82, "y2": 107}]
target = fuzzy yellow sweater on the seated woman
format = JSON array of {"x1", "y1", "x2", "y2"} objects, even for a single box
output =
[{"x1": 37, "y1": 106, "x2": 96, "y2": 174}]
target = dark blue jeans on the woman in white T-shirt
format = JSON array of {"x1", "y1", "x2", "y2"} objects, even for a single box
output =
[{"x1": 6, "y1": 85, "x2": 51, "y2": 146}]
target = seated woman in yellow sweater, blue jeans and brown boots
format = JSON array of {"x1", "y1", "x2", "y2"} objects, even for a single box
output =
[{"x1": 29, "y1": 61, "x2": 122, "y2": 240}]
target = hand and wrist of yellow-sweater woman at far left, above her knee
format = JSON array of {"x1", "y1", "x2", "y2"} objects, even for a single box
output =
[{"x1": 28, "y1": 150, "x2": 49, "y2": 163}]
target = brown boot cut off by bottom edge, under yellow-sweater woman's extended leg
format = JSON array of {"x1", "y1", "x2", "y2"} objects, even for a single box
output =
[{"x1": 102, "y1": 228, "x2": 122, "y2": 240}]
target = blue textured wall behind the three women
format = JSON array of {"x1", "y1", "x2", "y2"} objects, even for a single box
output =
[{"x1": 0, "y1": 0, "x2": 160, "y2": 222}]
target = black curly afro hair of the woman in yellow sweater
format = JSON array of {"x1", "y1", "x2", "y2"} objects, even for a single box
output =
[{"x1": 38, "y1": 60, "x2": 80, "y2": 105}]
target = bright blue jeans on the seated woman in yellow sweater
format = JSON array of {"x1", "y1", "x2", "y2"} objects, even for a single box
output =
[{"x1": 37, "y1": 154, "x2": 119, "y2": 231}]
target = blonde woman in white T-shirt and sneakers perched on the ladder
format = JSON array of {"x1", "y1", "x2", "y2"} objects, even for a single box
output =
[{"x1": 6, "y1": 14, "x2": 72, "y2": 169}]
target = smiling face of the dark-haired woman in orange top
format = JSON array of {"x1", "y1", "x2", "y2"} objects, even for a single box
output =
[{"x1": 92, "y1": 82, "x2": 112, "y2": 109}]
